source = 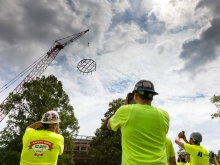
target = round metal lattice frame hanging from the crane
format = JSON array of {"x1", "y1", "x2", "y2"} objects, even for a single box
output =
[{"x1": 77, "y1": 59, "x2": 96, "y2": 75}]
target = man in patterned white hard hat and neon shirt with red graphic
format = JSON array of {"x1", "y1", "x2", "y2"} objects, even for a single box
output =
[{"x1": 20, "y1": 111, "x2": 64, "y2": 165}]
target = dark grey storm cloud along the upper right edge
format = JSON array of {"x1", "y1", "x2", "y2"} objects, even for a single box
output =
[{"x1": 180, "y1": 0, "x2": 220, "y2": 73}]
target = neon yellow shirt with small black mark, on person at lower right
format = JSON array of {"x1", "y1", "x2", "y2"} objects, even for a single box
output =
[{"x1": 184, "y1": 143, "x2": 209, "y2": 165}]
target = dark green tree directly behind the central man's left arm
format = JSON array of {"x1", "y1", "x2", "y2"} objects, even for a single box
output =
[{"x1": 89, "y1": 98, "x2": 124, "y2": 165}]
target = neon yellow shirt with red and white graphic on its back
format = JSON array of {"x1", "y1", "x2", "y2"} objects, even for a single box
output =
[{"x1": 20, "y1": 128, "x2": 64, "y2": 165}]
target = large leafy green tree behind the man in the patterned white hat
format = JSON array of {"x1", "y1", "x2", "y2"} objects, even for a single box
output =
[{"x1": 0, "y1": 75, "x2": 79, "y2": 165}]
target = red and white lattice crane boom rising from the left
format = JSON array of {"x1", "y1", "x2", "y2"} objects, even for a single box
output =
[{"x1": 0, "y1": 29, "x2": 90, "y2": 122}]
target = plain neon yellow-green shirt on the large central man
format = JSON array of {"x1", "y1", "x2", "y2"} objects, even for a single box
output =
[{"x1": 110, "y1": 104, "x2": 169, "y2": 165}]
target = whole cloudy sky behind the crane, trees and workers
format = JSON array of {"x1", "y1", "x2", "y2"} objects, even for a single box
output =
[{"x1": 0, "y1": 0, "x2": 220, "y2": 152}]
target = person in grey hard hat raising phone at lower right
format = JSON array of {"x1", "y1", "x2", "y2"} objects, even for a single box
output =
[{"x1": 175, "y1": 131, "x2": 209, "y2": 165}]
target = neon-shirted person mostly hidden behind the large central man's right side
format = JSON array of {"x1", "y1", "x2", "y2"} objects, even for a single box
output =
[{"x1": 166, "y1": 137, "x2": 176, "y2": 165}]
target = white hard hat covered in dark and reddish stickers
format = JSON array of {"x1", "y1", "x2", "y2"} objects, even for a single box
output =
[{"x1": 41, "y1": 111, "x2": 60, "y2": 124}]
